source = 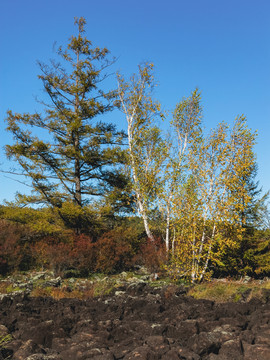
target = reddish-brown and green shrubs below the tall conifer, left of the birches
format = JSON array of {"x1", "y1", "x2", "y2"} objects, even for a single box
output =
[{"x1": 0, "y1": 204, "x2": 166, "y2": 276}]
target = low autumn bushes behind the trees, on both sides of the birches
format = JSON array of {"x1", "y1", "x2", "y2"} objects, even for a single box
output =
[{"x1": 0, "y1": 207, "x2": 270, "y2": 279}]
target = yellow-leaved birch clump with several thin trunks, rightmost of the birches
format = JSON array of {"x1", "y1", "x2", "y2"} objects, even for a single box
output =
[{"x1": 170, "y1": 116, "x2": 255, "y2": 282}]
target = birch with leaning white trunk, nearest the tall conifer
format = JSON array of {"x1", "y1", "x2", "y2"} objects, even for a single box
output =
[{"x1": 118, "y1": 64, "x2": 166, "y2": 241}]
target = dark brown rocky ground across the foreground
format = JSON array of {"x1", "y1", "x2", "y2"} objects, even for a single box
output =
[{"x1": 0, "y1": 282, "x2": 270, "y2": 360}]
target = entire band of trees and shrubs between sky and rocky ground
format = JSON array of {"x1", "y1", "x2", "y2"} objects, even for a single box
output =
[{"x1": 0, "y1": 18, "x2": 269, "y2": 282}]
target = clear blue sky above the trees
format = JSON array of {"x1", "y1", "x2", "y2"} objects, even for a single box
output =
[{"x1": 0, "y1": 0, "x2": 270, "y2": 202}]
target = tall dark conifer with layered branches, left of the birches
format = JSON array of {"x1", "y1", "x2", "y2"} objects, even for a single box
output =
[{"x1": 6, "y1": 18, "x2": 125, "y2": 208}]
